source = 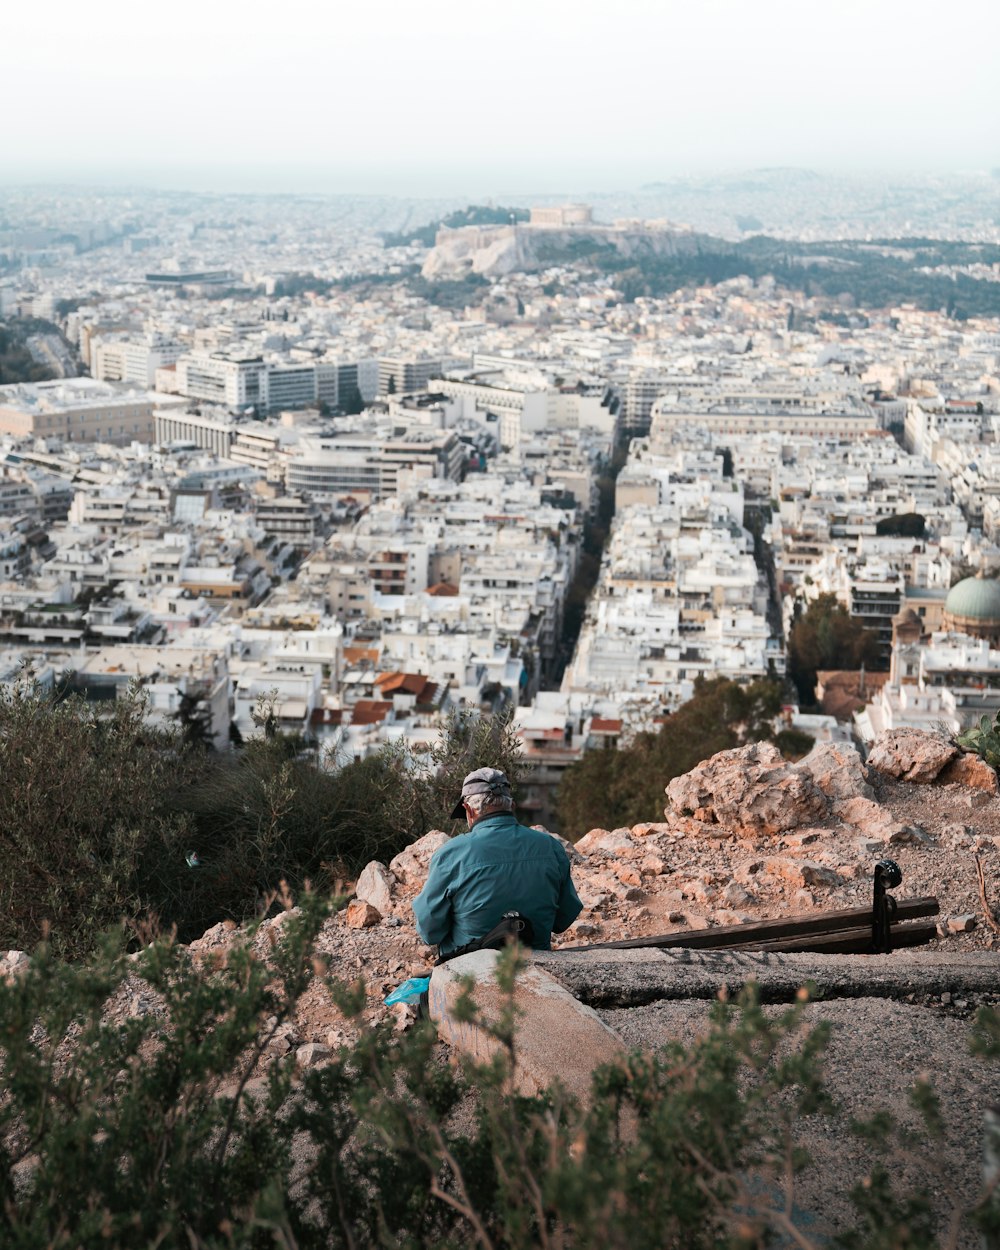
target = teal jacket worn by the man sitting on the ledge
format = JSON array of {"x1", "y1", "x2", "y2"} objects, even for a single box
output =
[{"x1": 414, "y1": 811, "x2": 583, "y2": 955}]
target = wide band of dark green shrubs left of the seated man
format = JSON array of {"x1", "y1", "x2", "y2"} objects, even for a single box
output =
[{"x1": 0, "y1": 684, "x2": 523, "y2": 956}]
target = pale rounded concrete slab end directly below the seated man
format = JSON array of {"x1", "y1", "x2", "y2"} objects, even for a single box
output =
[{"x1": 429, "y1": 950, "x2": 625, "y2": 1103}]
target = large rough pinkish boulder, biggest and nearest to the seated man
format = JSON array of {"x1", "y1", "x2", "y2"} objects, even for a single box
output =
[{"x1": 666, "y1": 743, "x2": 829, "y2": 835}]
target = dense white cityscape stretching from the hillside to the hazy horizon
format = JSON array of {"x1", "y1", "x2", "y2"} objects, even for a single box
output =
[{"x1": 0, "y1": 170, "x2": 1000, "y2": 820}]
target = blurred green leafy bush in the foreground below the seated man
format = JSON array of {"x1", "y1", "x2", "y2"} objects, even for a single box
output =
[{"x1": 0, "y1": 894, "x2": 998, "y2": 1250}]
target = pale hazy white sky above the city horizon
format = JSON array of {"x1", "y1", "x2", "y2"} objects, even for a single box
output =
[{"x1": 0, "y1": 0, "x2": 1000, "y2": 195}]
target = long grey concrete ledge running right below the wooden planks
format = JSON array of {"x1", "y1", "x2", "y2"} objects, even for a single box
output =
[{"x1": 535, "y1": 949, "x2": 1000, "y2": 1008}]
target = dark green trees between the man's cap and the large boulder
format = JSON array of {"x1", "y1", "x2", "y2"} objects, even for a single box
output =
[{"x1": 556, "y1": 678, "x2": 781, "y2": 838}]
